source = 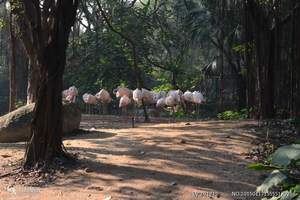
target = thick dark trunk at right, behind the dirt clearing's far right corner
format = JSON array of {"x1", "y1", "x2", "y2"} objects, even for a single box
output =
[{"x1": 246, "y1": 0, "x2": 276, "y2": 119}]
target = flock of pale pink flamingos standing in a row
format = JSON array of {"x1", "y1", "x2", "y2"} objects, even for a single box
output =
[{"x1": 62, "y1": 86, "x2": 204, "y2": 115}]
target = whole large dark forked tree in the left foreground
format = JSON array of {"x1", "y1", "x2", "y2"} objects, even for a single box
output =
[{"x1": 11, "y1": 0, "x2": 78, "y2": 167}]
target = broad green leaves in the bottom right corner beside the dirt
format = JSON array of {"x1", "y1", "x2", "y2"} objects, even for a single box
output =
[{"x1": 248, "y1": 144, "x2": 300, "y2": 200}]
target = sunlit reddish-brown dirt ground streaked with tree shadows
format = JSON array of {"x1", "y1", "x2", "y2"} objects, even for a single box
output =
[{"x1": 0, "y1": 116, "x2": 264, "y2": 200}]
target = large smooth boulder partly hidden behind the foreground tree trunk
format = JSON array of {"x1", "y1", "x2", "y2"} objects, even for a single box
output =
[{"x1": 0, "y1": 103, "x2": 81, "y2": 142}]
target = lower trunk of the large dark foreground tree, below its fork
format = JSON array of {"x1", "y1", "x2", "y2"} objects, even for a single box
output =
[{"x1": 25, "y1": 61, "x2": 64, "y2": 166}]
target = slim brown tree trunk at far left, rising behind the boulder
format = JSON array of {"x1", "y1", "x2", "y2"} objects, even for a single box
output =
[{"x1": 9, "y1": 12, "x2": 17, "y2": 112}]
